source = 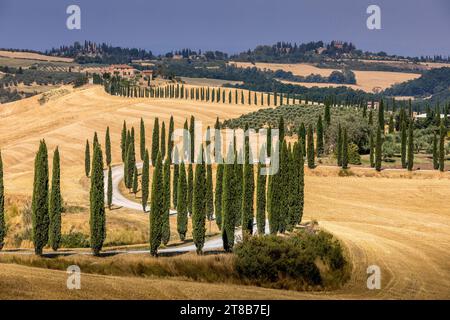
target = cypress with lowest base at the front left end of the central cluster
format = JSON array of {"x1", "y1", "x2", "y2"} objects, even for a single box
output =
[{"x1": 149, "y1": 152, "x2": 164, "y2": 256}]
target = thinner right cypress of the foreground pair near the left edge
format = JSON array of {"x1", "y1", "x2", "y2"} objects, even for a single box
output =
[{"x1": 48, "y1": 148, "x2": 62, "y2": 251}]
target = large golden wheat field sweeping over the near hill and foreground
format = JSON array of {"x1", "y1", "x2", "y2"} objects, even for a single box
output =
[{"x1": 0, "y1": 86, "x2": 450, "y2": 299}]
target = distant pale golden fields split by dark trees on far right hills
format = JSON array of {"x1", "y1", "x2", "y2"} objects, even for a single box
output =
[{"x1": 232, "y1": 62, "x2": 420, "y2": 92}]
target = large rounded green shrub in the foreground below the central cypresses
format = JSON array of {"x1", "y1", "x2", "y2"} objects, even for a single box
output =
[{"x1": 234, "y1": 230, "x2": 348, "y2": 290}]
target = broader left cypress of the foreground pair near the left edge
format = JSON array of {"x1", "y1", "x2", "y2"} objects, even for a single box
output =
[{"x1": 32, "y1": 140, "x2": 49, "y2": 255}]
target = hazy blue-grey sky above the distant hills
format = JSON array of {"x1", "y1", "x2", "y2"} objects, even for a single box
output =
[{"x1": 0, "y1": 0, "x2": 450, "y2": 56}]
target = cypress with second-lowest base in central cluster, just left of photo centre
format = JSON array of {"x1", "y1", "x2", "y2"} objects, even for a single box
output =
[{"x1": 192, "y1": 146, "x2": 206, "y2": 254}]
